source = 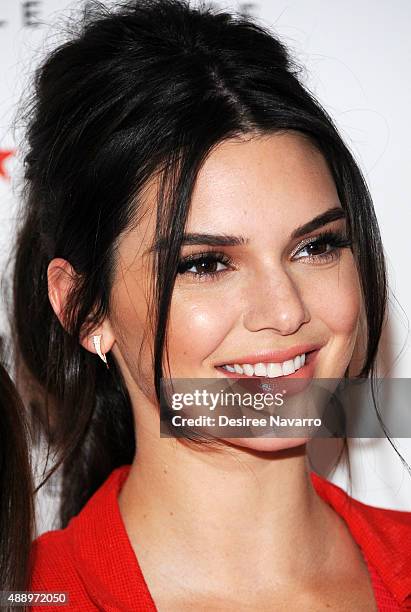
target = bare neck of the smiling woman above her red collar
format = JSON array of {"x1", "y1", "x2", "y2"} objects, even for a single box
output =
[{"x1": 119, "y1": 429, "x2": 335, "y2": 580}]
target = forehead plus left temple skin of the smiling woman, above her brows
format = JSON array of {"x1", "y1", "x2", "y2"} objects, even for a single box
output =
[{"x1": 120, "y1": 132, "x2": 340, "y2": 259}]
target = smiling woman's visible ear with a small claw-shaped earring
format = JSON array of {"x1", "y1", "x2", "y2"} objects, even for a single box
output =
[{"x1": 47, "y1": 257, "x2": 115, "y2": 354}]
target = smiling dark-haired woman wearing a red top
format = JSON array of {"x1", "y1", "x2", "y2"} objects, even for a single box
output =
[{"x1": 14, "y1": 0, "x2": 411, "y2": 611}]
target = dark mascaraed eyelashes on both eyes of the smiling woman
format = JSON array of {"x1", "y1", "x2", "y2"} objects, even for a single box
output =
[{"x1": 177, "y1": 231, "x2": 352, "y2": 280}]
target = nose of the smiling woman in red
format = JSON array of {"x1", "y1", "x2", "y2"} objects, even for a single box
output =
[{"x1": 243, "y1": 268, "x2": 310, "y2": 336}]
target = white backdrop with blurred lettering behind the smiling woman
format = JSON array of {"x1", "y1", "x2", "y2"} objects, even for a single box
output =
[{"x1": 0, "y1": 0, "x2": 411, "y2": 524}]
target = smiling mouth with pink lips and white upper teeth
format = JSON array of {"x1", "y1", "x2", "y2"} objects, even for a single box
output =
[{"x1": 215, "y1": 349, "x2": 319, "y2": 378}]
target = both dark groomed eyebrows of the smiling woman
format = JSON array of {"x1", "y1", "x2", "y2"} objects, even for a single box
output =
[{"x1": 147, "y1": 206, "x2": 347, "y2": 253}]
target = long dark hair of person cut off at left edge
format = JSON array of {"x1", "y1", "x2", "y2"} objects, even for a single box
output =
[{"x1": 0, "y1": 350, "x2": 34, "y2": 596}]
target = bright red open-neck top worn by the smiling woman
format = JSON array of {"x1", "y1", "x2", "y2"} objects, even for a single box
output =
[{"x1": 30, "y1": 465, "x2": 411, "y2": 612}]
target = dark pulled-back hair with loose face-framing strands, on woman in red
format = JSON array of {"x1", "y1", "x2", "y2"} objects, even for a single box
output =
[{"x1": 14, "y1": 0, "x2": 387, "y2": 526}]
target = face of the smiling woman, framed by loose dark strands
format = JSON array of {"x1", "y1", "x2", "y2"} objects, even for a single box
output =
[{"x1": 110, "y1": 132, "x2": 361, "y2": 450}]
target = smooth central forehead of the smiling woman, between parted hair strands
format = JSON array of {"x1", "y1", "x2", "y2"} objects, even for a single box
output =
[{"x1": 188, "y1": 132, "x2": 339, "y2": 231}]
